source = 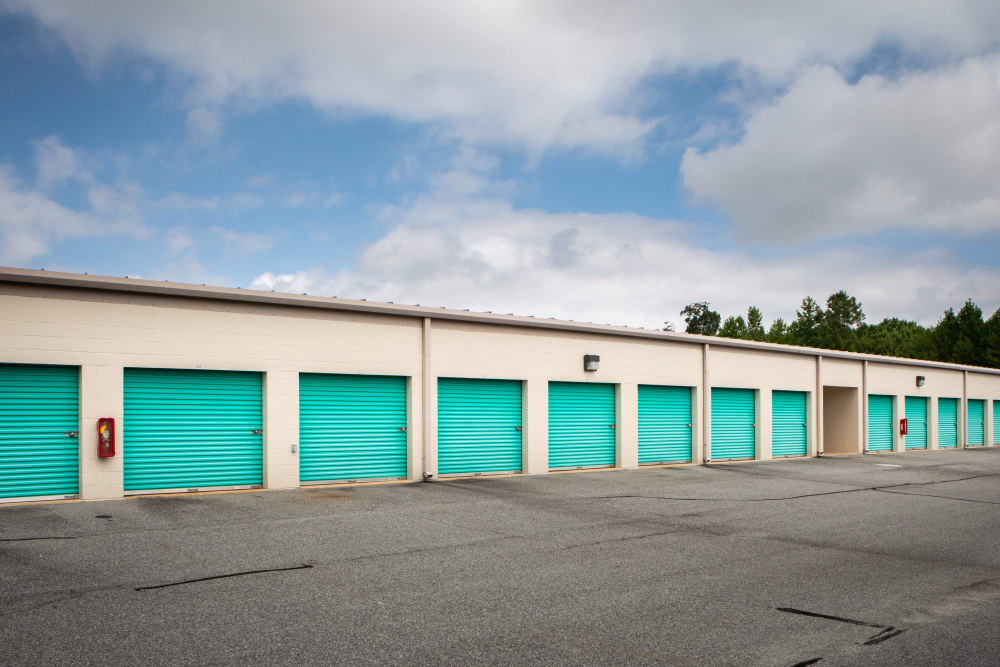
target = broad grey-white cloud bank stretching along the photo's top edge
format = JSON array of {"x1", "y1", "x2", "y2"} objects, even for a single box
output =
[{"x1": 10, "y1": 0, "x2": 1000, "y2": 157}]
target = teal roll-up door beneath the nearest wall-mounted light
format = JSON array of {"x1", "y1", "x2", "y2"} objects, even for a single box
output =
[{"x1": 549, "y1": 382, "x2": 615, "y2": 468}]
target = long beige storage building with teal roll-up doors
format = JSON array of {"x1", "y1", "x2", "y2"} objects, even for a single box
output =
[{"x1": 0, "y1": 269, "x2": 1000, "y2": 501}]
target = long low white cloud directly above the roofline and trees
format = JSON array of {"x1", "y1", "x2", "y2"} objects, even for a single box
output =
[{"x1": 252, "y1": 180, "x2": 1000, "y2": 327}]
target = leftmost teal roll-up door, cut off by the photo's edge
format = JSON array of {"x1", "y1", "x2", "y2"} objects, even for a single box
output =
[{"x1": 0, "y1": 364, "x2": 80, "y2": 498}]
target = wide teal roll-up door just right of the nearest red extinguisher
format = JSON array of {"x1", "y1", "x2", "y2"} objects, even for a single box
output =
[{"x1": 122, "y1": 368, "x2": 263, "y2": 492}]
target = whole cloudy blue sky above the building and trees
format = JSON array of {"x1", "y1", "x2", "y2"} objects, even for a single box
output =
[{"x1": 0, "y1": 0, "x2": 1000, "y2": 327}]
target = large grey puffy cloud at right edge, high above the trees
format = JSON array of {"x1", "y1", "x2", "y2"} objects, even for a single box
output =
[{"x1": 681, "y1": 59, "x2": 1000, "y2": 241}]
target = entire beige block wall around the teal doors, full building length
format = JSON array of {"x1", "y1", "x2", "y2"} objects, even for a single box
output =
[{"x1": 0, "y1": 285, "x2": 1000, "y2": 499}]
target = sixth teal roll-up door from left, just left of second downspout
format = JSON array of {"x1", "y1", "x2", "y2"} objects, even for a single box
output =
[{"x1": 639, "y1": 384, "x2": 691, "y2": 463}]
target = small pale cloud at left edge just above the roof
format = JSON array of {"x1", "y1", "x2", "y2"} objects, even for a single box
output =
[{"x1": 0, "y1": 165, "x2": 146, "y2": 265}]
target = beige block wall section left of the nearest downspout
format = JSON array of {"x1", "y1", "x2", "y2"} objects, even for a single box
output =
[{"x1": 0, "y1": 286, "x2": 422, "y2": 499}]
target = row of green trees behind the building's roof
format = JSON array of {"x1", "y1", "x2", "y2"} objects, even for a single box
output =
[{"x1": 680, "y1": 290, "x2": 1000, "y2": 368}]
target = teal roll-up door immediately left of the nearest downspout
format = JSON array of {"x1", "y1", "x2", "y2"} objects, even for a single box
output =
[{"x1": 299, "y1": 373, "x2": 406, "y2": 483}]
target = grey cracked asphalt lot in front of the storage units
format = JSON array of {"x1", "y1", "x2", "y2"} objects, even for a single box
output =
[{"x1": 0, "y1": 449, "x2": 1000, "y2": 665}]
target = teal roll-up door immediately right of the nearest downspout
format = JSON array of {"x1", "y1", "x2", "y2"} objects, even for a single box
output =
[{"x1": 438, "y1": 378, "x2": 521, "y2": 475}]
